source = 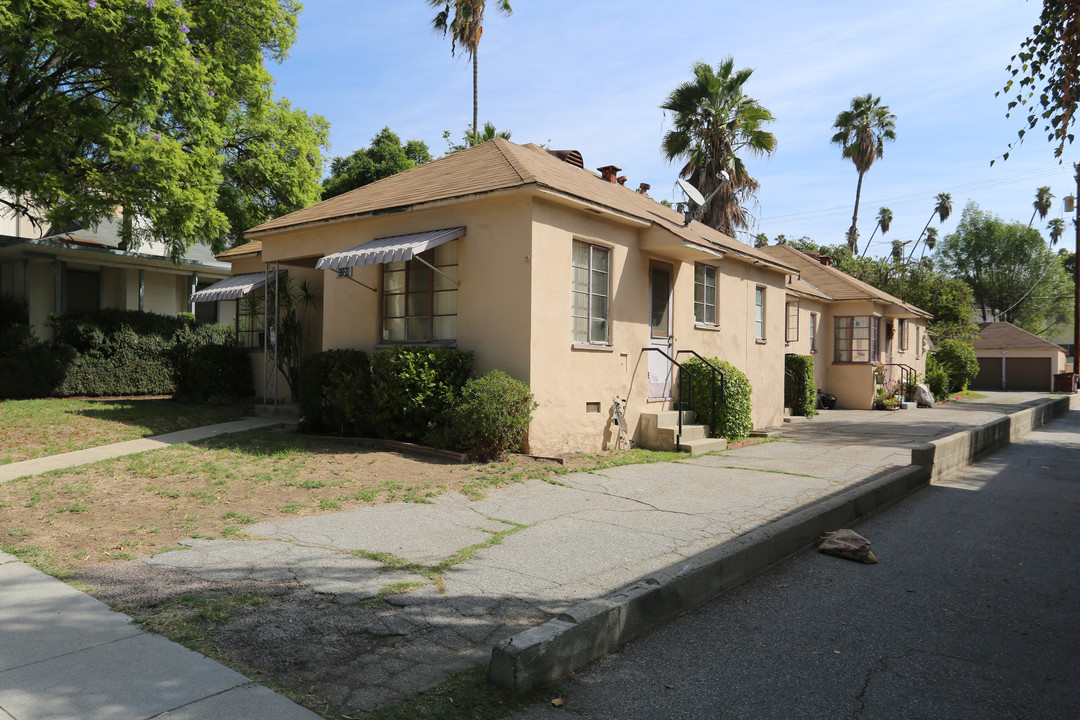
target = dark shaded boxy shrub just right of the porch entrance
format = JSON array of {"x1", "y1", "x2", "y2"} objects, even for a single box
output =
[{"x1": 300, "y1": 350, "x2": 373, "y2": 435}]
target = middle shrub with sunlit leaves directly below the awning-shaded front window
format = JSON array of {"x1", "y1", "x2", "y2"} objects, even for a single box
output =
[{"x1": 370, "y1": 345, "x2": 473, "y2": 440}]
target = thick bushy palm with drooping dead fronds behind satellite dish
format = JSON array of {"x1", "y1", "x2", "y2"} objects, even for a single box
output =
[{"x1": 660, "y1": 56, "x2": 777, "y2": 235}]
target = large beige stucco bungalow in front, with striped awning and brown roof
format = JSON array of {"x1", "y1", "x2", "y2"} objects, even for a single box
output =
[{"x1": 206, "y1": 138, "x2": 807, "y2": 454}]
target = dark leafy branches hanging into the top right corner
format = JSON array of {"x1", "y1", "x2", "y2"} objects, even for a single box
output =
[{"x1": 990, "y1": 0, "x2": 1080, "y2": 158}]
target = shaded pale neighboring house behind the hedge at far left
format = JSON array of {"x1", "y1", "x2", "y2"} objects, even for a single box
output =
[{"x1": 0, "y1": 202, "x2": 233, "y2": 338}]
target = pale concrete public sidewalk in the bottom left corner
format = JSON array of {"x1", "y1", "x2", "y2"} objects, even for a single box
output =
[{"x1": 0, "y1": 553, "x2": 319, "y2": 720}]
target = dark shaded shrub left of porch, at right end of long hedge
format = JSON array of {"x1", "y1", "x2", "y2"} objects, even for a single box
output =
[{"x1": 174, "y1": 344, "x2": 255, "y2": 404}]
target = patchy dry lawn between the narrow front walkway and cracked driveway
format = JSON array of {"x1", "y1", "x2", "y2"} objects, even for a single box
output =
[{"x1": 0, "y1": 433, "x2": 617, "y2": 574}]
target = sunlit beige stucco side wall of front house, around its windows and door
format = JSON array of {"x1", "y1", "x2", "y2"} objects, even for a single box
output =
[{"x1": 522, "y1": 201, "x2": 784, "y2": 453}]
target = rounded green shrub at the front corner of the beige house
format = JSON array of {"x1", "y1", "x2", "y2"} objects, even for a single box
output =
[{"x1": 429, "y1": 370, "x2": 537, "y2": 462}]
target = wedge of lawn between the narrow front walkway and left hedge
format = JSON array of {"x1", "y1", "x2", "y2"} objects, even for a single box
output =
[{"x1": 0, "y1": 398, "x2": 244, "y2": 465}]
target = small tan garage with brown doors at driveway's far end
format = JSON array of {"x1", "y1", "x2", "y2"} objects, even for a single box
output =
[{"x1": 970, "y1": 322, "x2": 1066, "y2": 392}]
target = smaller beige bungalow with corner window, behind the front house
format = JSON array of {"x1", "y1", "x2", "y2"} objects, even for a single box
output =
[{"x1": 760, "y1": 245, "x2": 930, "y2": 409}]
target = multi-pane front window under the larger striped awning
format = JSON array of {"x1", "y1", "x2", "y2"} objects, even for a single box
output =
[{"x1": 382, "y1": 241, "x2": 458, "y2": 342}]
